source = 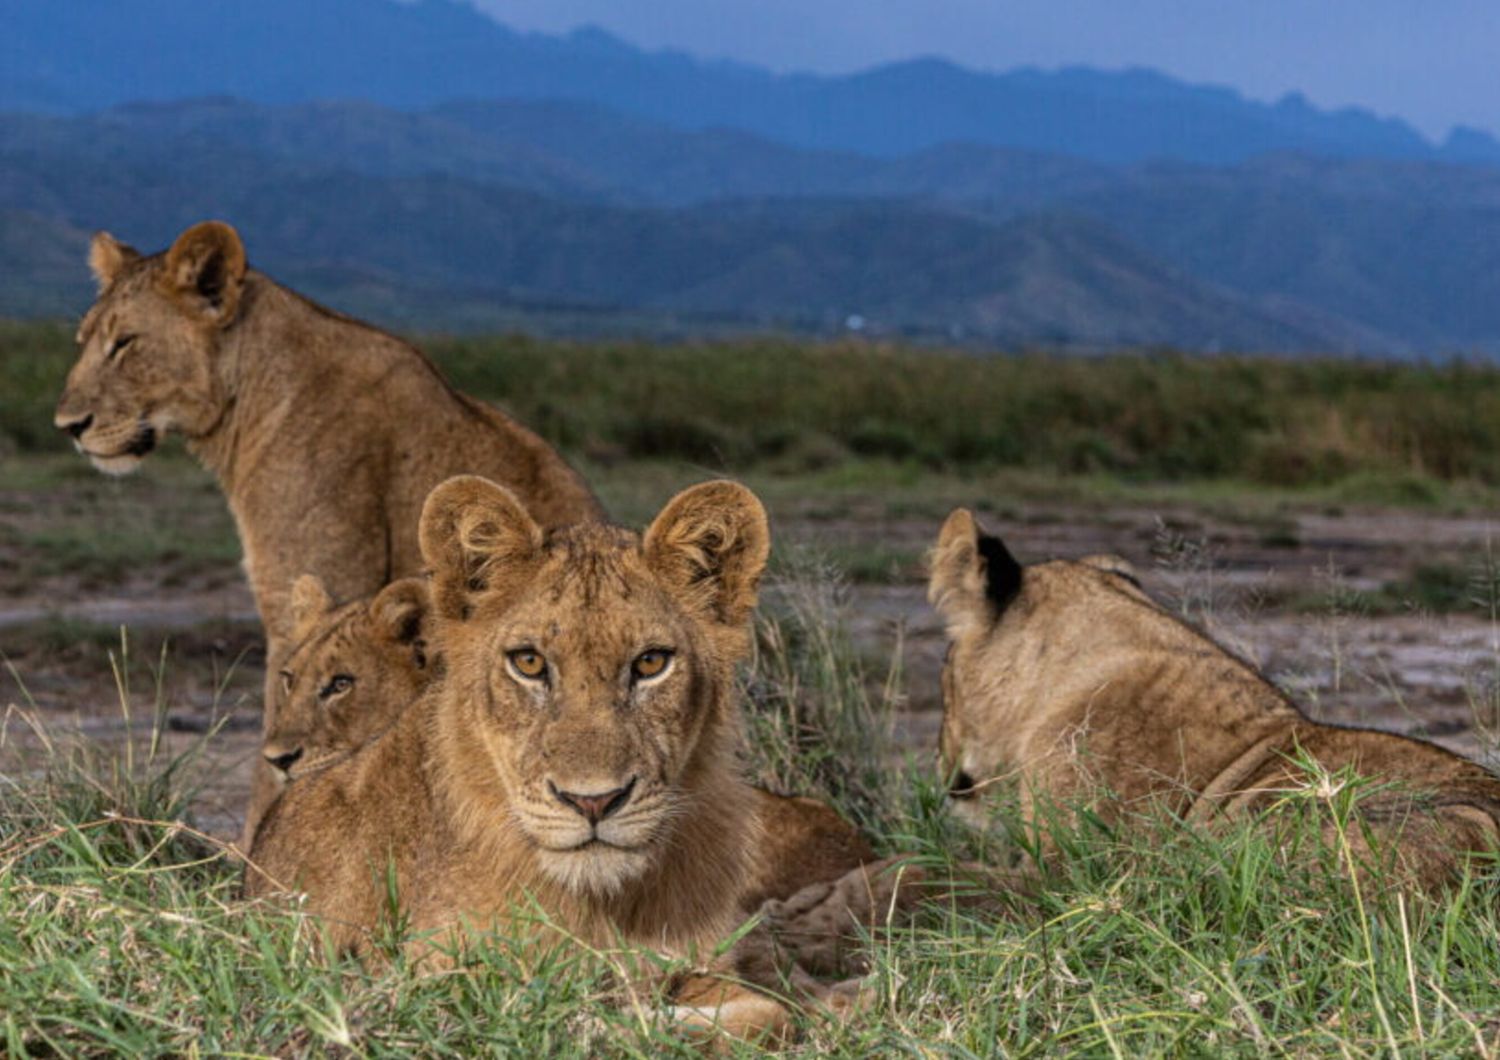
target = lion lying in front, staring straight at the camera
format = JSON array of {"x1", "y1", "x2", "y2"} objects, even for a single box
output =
[{"x1": 246, "y1": 475, "x2": 804, "y2": 1030}]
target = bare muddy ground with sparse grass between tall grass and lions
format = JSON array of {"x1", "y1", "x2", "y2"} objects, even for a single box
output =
[{"x1": 0, "y1": 456, "x2": 1500, "y2": 834}]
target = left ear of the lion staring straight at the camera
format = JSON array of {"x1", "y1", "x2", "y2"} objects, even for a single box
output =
[{"x1": 419, "y1": 475, "x2": 542, "y2": 619}]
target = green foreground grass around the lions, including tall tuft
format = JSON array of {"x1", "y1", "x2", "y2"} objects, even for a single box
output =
[{"x1": 0, "y1": 572, "x2": 1500, "y2": 1059}]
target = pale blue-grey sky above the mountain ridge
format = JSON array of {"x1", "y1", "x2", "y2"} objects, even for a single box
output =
[{"x1": 473, "y1": 0, "x2": 1500, "y2": 136}]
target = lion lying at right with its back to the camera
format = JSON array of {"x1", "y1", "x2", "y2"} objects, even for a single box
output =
[{"x1": 929, "y1": 508, "x2": 1500, "y2": 892}]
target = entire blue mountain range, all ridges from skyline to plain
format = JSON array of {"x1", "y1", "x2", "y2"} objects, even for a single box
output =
[{"x1": 0, "y1": 0, "x2": 1500, "y2": 355}]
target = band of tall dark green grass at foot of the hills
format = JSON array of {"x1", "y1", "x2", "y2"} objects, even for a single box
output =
[{"x1": 0, "y1": 322, "x2": 1500, "y2": 507}]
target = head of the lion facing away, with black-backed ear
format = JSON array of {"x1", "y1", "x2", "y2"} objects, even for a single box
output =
[{"x1": 927, "y1": 508, "x2": 1149, "y2": 826}]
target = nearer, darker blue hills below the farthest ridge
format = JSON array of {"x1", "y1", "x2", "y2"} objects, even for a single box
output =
[{"x1": 0, "y1": 99, "x2": 1500, "y2": 354}]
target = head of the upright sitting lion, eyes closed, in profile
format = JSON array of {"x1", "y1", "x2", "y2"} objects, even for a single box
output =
[{"x1": 56, "y1": 222, "x2": 245, "y2": 474}]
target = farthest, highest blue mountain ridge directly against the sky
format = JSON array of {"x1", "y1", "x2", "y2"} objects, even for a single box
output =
[{"x1": 0, "y1": 0, "x2": 1500, "y2": 165}]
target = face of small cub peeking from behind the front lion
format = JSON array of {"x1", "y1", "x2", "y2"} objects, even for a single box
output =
[{"x1": 261, "y1": 576, "x2": 435, "y2": 781}]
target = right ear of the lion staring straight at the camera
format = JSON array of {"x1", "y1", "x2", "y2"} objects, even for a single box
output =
[{"x1": 642, "y1": 481, "x2": 771, "y2": 625}]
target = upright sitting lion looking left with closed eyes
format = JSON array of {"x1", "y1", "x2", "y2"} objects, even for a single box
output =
[{"x1": 56, "y1": 220, "x2": 600, "y2": 647}]
